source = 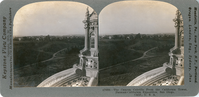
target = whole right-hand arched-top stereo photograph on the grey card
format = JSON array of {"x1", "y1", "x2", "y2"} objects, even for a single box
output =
[{"x1": 98, "y1": 1, "x2": 184, "y2": 86}]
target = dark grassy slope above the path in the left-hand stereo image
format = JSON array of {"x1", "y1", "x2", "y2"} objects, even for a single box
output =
[{"x1": 13, "y1": 41, "x2": 82, "y2": 69}]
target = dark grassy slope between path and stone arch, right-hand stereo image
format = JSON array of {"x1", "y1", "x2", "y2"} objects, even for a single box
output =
[{"x1": 99, "y1": 52, "x2": 169, "y2": 86}]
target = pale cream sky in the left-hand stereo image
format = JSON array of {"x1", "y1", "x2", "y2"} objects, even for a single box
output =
[{"x1": 13, "y1": 1, "x2": 93, "y2": 36}]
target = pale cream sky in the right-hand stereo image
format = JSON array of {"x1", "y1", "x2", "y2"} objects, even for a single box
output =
[{"x1": 99, "y1": 1, "x2": 177, "y2": 35}]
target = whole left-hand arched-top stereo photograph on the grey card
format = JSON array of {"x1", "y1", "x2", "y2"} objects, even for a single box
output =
[{"x1": 13, "y1": 1, "x2": 99, "y2": 87}]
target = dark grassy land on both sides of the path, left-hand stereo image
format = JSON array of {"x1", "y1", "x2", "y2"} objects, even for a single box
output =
[{"x1": 14, "y1": 41, "x2": 83, "y2": 87}]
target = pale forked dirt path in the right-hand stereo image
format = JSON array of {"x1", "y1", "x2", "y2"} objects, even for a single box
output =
[{"x1": 99, "y1": 47, "x2": 157, "y2": 71}]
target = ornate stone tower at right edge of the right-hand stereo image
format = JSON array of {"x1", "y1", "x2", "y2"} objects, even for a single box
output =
[{"x1": 169, "y1": 10, "x2": 184, "y2": 76}]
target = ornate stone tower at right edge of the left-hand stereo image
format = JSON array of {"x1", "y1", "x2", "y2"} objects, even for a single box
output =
[{"x1": 78, "y1": 8, "x2": 99, "y2": 78}]
